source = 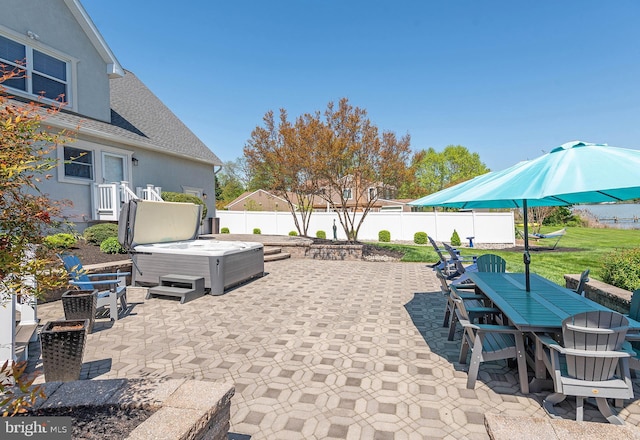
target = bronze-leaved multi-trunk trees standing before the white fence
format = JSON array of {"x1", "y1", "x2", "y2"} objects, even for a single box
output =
[{"x1": 244, "y1": 98, "x2": 410, "y2": 240}]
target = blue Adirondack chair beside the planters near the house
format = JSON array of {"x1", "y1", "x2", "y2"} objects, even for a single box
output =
[{"x1": 58, "y1": 254, "x2": 130, "y2": 321}]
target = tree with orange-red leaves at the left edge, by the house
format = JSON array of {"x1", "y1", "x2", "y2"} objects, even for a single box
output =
[{"x1": 0, "y1": 69, "x2": 68, "y2": 295}]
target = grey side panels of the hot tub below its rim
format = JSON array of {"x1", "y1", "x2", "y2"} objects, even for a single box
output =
[{"x1": 133, "y1": 243, "x2": 264, "y2": 295}]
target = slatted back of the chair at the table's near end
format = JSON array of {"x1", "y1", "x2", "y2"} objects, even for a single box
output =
[{"x1": 562, "y1": 311, "x2": 629, "y2": 381}]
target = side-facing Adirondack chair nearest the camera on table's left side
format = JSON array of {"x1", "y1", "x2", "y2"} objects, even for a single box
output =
[{"x1": 455, "y1": 298, "x2": 529, "y2": 394}]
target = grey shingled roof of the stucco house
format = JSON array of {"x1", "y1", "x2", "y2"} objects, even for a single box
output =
[{"x1": 23, "y1": 70, "x2": 222, "y2": 165}]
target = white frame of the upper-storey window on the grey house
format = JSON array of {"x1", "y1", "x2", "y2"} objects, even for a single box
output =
[{"x1": 0, "y1": 25, "x2": 79, "y2": 111}]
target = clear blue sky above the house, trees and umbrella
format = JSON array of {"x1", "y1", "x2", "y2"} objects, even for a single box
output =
[{"x1": 83, "y1": 0, "x2": 640, "y2": 170}]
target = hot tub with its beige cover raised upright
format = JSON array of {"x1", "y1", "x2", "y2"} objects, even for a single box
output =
[{"x1": 118, "y1": 200, "x2": 264, "y2": 295}]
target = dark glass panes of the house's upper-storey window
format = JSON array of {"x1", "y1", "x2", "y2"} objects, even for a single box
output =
[{"x1": 0, "y1": 35, "x2": 69, "y2": 102}]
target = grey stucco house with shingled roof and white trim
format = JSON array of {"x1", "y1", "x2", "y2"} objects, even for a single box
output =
[{"x1": 0, "y1": 0, "x2": 222, "y2": 232}]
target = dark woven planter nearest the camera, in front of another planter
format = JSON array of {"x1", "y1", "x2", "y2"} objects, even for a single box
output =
[{"x1": 40, "y1": 319, "x2": 89, "y2": 382}]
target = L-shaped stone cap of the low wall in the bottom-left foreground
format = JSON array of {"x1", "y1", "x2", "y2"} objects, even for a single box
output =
[{"x1": 34, "y1": 379, "x2": 235, "y2": 440}]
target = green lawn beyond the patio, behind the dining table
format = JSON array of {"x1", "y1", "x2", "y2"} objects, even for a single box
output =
[{"x1": 376, "y1": 227, "x2": 640, "y2": 285}]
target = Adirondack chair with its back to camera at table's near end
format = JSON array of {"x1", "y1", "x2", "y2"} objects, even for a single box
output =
[{"x1": 536, "y1": 311, "x2": 633, "y2": 425}]
